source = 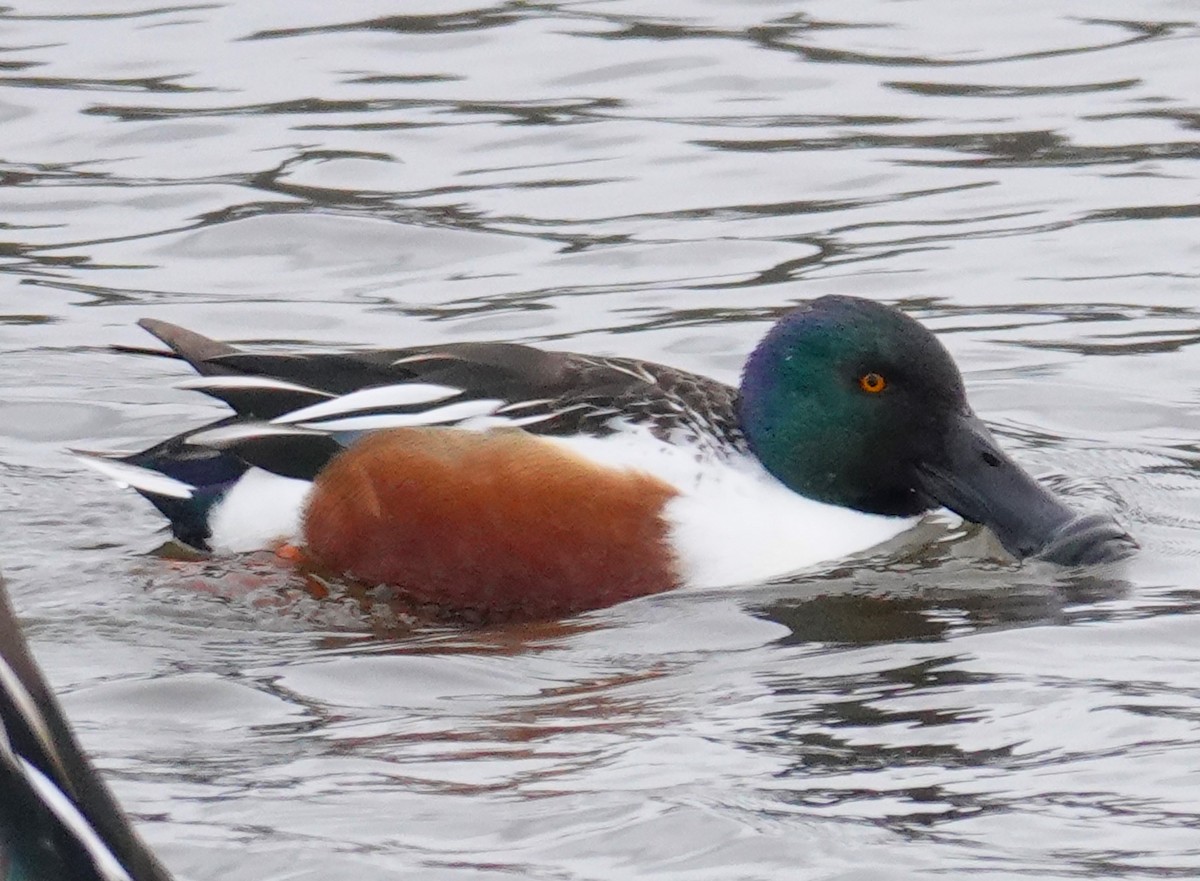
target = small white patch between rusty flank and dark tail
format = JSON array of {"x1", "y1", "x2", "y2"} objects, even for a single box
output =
[{"x1": 209, "y1": 468, "x2": 312, "y2": 553}]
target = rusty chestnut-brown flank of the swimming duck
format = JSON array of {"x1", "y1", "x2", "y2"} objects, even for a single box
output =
[{"x1": 304, "y1": 428, "x2": 678, "y2": 618}]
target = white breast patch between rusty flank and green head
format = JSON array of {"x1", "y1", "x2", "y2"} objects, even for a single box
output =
[{"x1": 546, "y1": 428, "x2": 918, "y2": 588}]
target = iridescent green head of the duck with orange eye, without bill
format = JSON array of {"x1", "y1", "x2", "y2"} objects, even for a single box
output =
[{"x1": 739, "y1": 296, "x2": 968, "y2": 515}]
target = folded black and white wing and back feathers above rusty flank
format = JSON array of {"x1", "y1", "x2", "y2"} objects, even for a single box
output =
[{"x1": 133, "y1": 320, "x2": 744, "y2": 478}]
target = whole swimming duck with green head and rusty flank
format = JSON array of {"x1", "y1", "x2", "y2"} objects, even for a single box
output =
[{"x1": 86, "y1": 295, "x2": 1136, "y2": 617}]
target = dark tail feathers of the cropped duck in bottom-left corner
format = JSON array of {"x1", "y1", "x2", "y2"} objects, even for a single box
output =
[{"x1": 0, "y1": 580, "x2": 172, "y2": 881}]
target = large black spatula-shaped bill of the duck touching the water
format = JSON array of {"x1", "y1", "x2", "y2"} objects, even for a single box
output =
[{"x1": 922, "y1": 414, "x2": 1138, "y2": 565}]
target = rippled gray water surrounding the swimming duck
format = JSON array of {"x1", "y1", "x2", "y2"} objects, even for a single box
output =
[{"x1": 0, "y1": 0, "x2": 1200, "y2": 881}]
